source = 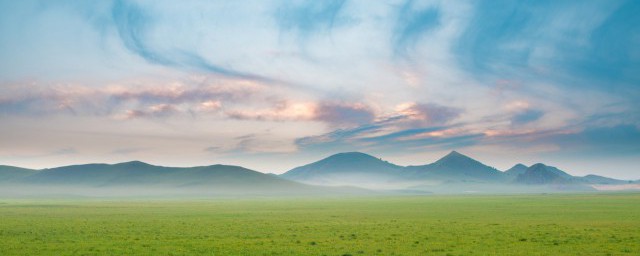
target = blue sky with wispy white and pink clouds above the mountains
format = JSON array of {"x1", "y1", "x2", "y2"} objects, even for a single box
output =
[{"x1": 0, "y1": 0, "x2": 640, "y2": 179}]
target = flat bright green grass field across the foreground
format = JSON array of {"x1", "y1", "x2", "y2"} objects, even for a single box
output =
[{"x1": 0, "y1": 193, "x2": 640, "y2": 255}]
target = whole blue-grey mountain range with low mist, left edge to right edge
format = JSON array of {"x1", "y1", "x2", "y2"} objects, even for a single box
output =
[{"x1": 0, "y1": 151, "x2": 638, "y2": 195}]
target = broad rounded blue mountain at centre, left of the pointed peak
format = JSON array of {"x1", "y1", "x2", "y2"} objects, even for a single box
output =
[{"x1": 281, "y1": 152, "x2": 403, "y2": 187}]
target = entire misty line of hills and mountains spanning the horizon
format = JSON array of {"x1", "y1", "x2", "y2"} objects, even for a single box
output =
[{"x1": 0, "y1": 150, "x2": 635, "y2": 194}]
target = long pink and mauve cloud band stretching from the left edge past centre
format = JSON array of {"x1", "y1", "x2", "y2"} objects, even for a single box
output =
[{"x1": 0, "y1": 78, "x2": 377, "y2": 127}]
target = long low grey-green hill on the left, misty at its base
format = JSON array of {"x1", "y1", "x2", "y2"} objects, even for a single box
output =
[{"x1": 21, "y1": 161, "x2": 302, "y2": 188}]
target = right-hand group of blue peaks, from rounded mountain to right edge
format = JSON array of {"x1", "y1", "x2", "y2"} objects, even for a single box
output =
[{"x1": 281, "y1": 151, "x2": 634, "y2": 192}]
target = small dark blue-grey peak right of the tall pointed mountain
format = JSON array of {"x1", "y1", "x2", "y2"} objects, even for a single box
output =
[{"x1": 515, "y1": 163, "x2": 581, "y2": 185}]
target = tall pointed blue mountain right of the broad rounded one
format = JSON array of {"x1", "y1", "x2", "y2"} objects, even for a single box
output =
[{"x1": 407, "y1": 151, "x2": 505, "y2": 182}]
